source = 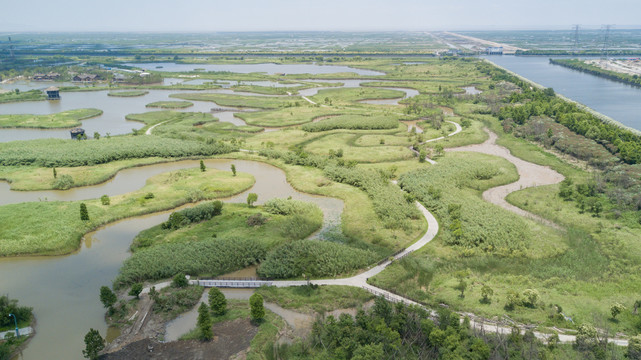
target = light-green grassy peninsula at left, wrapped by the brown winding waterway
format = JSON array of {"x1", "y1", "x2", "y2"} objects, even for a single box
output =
[{"x1": 0, "y1": 168, "x2": 254, "y2": 256}]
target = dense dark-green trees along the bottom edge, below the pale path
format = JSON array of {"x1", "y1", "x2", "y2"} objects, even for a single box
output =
[{"x1": 276, "y1": 297, "x2": 608, "y2": 360}]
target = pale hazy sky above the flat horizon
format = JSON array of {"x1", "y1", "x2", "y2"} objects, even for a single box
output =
[{"x1": 0, "y1": 0, "x2": 641, "y2": 32}]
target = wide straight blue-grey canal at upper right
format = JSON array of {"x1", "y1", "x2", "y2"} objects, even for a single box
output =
[{"x1": 483, "y1": 56, "x2": 641, "y2": 130}]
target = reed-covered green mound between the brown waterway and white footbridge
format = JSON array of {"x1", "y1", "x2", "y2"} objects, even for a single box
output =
[{"x1": 115, "y1": 199, "x2": 323, "y2": 286}]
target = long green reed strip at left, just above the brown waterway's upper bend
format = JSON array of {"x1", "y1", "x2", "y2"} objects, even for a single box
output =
[{"x1": 0, "y1": 136, "x2": 235, "y2": 167}]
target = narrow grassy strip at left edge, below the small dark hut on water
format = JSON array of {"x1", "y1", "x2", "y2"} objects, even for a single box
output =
[{"x1": 0, "y1": 109, "x2": 102, "y2": 129}]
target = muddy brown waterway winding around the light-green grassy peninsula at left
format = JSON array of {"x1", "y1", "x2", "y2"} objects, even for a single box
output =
[{"x1": 0, "y1": 159, "x2": 343, "y2": 359}]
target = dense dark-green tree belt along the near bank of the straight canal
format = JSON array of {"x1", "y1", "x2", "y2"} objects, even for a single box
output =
[{"x1": 477, "y1": 63, "x2": 641, "y2": 164}]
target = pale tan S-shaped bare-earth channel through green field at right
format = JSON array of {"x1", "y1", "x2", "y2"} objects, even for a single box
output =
[{"x1": 446, "y1": 129, "x2": 564, "y2": 229}]
